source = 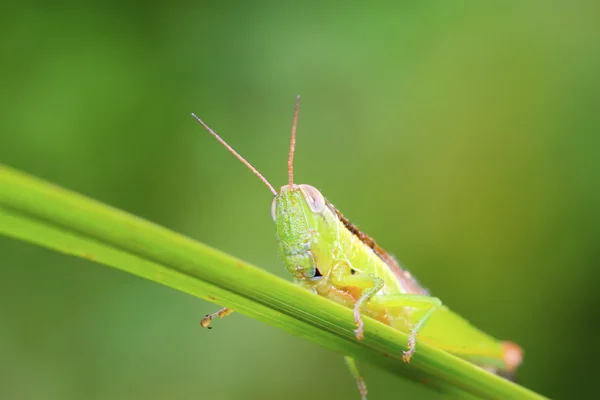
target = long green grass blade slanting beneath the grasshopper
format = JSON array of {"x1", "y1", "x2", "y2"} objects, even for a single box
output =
[{"x1": 0, "y1": 165, "x2": 544, "y2": 399}]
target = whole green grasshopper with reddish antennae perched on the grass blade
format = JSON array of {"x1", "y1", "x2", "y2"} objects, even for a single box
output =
[{"x1": 192, "y1": 96, "x2": 522, "y2": 400}]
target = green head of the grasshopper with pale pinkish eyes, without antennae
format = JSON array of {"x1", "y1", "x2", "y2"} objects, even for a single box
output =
[{"x1": 271, "y1": 184, "x2": 327, "y2": 279}]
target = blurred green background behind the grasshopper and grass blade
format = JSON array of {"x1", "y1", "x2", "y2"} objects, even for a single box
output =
[{"x1": 0, "y1": 1, "x2": 600, "y2": 400}]
